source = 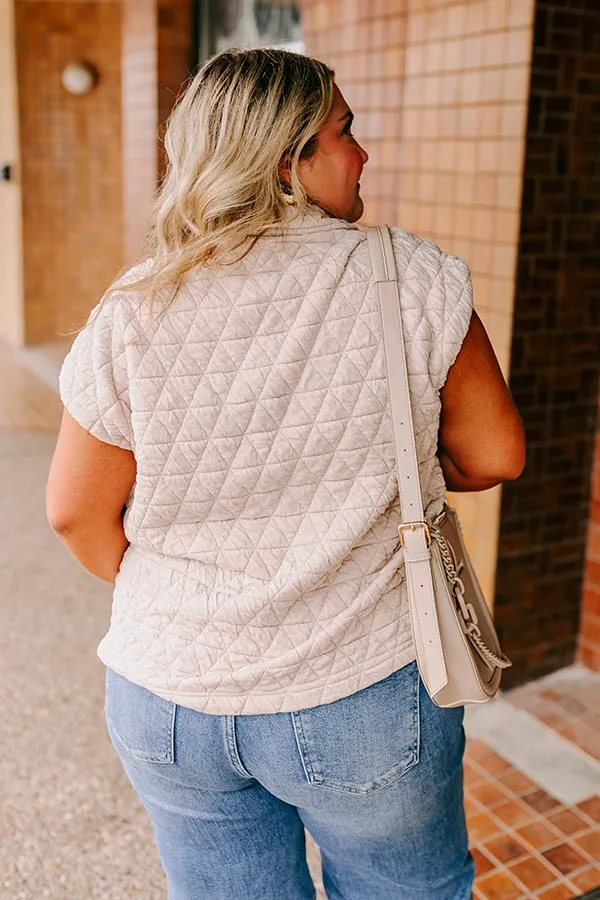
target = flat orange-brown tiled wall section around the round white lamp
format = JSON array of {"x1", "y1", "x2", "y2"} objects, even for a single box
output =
[{"x1": 15, "y1": 0, "x2": 122, "y2": 344}]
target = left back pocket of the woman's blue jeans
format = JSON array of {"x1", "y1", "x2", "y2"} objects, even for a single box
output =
[{"x1": 106, "y1": 669, "x2": 177, "y2": 765}]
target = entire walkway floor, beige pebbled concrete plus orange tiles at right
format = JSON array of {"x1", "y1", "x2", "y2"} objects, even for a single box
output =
[{"x1": 0, "y1": 348, "x2": 600, "y2": 900}]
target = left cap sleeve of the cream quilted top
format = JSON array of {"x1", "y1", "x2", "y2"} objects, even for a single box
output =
[{"x1": 59, "y1": 294, "x2": 133, "y2": 450}]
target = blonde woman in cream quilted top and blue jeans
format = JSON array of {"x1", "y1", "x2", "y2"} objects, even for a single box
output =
[{"x1": 48, "y1": 50, "x2": 524, "y2": 900}]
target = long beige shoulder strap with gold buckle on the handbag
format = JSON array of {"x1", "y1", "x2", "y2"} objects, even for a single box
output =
[{"x1": 367, "y1": 226, "x2": 448, "y2": 694}]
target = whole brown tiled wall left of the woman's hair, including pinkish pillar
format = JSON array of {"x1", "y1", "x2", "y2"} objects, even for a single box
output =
[{"x1": 11, "y1": 0, "x2": 192, "y2": 334}]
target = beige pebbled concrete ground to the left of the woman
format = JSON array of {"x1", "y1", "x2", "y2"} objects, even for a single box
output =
[{"x1": 0, "y1": 429, "x2": 326, "y2": 900}]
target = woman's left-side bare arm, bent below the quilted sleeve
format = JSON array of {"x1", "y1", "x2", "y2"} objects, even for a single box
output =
[{"x1": 46, "y1": 411, "x2": 136, "y2": 582}]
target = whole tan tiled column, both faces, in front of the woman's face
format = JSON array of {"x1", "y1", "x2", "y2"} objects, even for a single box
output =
[{"x1": 302, "y1": 0, "x2": 534, "y2": 600}]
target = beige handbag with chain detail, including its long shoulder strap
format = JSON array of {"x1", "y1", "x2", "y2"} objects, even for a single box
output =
[{"x1": 367, "y1": 226, "x2": 511, "y2": 706}]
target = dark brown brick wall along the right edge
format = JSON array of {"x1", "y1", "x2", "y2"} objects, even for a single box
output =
[{"x1": 496, "y1": 0, "x2": 600, "y2": 683}]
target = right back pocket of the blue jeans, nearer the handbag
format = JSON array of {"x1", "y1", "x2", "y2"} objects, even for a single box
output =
[{"x1": 291, "y1": 663, "x2": 420, "y2": 794}]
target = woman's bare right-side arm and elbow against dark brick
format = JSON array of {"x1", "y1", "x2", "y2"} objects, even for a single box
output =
[{"x1": 438, "y1": 312, "x2": 525, "y2": 491}]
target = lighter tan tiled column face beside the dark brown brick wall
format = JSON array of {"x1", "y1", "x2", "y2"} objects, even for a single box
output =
[{"x1": 395, "y1": 0, "x2": 534, "y2": 601}]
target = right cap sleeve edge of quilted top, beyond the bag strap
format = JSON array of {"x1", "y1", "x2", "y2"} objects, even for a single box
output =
[{"x1": 436, "y1": 253, "x2": 473, "y2": 390}]
